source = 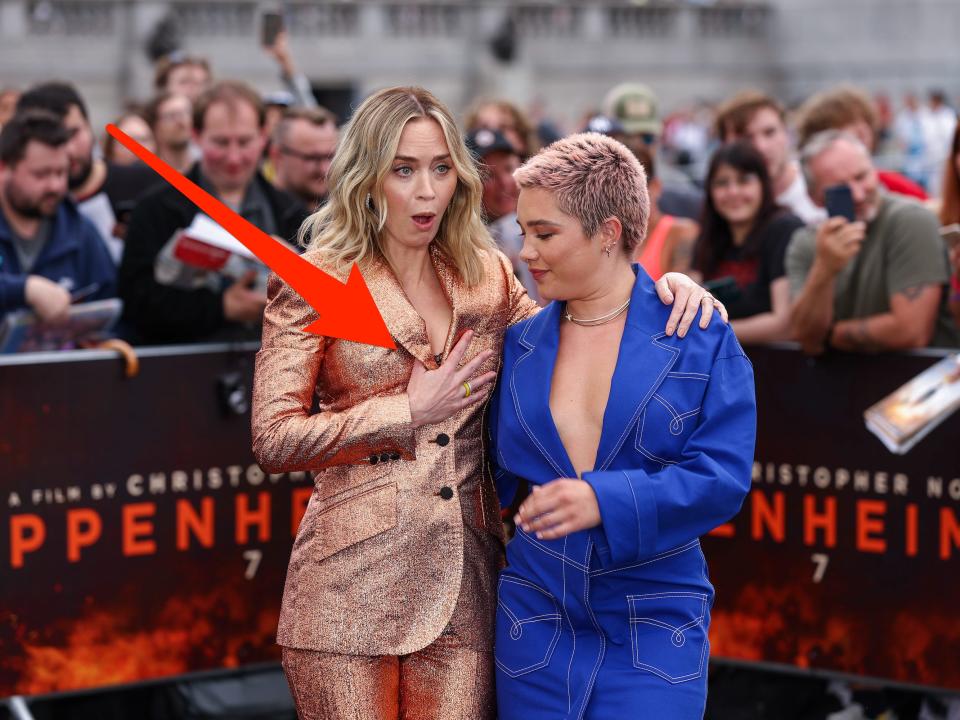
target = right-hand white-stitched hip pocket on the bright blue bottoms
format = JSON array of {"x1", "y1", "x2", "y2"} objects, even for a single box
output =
[{"x1": 627, "y1": 592, "x2": 709, "y2": 684}]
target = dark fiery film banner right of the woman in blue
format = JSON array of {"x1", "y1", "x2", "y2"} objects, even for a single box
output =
[{"x1": 703, "y1": 348, "x2": 960, "y2": 690}]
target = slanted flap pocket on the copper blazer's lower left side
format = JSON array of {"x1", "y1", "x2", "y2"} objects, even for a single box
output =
[{"x1": 314, "y1": 480, "x2": 397, "y2": 560}]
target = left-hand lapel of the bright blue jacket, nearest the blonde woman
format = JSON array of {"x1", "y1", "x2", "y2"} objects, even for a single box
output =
[{"x1": 508, "y1": 302, "x2": 576, "y2": 478}]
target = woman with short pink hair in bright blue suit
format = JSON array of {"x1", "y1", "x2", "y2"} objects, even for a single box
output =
[{"x1": 490, "y1": 133, "x2": 756, "y2": 720}]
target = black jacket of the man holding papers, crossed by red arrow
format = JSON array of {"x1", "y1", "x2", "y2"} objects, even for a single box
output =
[{"x1": 117, "y1": 165, "x2": 307, "y2": 344}]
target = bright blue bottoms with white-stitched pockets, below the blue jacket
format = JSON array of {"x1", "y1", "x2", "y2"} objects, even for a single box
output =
[{"x1": 494, "y1": 530, "x2": 713, "y2": 720}]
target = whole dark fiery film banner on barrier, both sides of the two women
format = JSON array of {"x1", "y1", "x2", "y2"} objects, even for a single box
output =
[{"x1": 0, "y1": 346, "x2": 960, "y2": 697}]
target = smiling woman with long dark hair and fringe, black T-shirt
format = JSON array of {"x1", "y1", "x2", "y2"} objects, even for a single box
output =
[{"x1": 693, "y1": 142, "x2": 803, "y2": 343}]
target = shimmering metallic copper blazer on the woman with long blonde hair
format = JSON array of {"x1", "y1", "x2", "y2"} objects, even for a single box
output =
[{"x1": 252, "y1": 243, "x2": 537, "y2": 655}]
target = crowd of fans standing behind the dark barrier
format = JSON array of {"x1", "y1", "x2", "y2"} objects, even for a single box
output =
[{"x1": 0, "y1": 52, "x2": 960, "y2": 354}]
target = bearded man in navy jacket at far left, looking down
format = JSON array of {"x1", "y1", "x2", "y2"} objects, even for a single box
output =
[{"x1": 0, "y1": 110, "x2": 116, "y2": 322}]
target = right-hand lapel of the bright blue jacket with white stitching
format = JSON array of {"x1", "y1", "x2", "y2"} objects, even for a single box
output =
[{"x1": 595, "y1": 265, "x2": 684, "y2": 470}]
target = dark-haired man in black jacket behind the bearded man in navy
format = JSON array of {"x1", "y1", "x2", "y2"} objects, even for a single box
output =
[{"x1": 17, "y1": 82, "x2": 157, "y2": 263}]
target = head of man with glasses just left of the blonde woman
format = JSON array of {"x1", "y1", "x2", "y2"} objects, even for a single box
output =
[{"x1": 270, "y1": 108, "x2": 338, "y2": 211}]
